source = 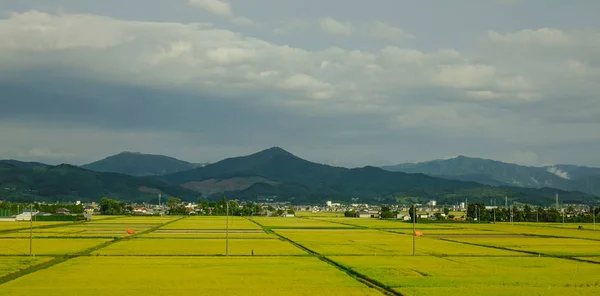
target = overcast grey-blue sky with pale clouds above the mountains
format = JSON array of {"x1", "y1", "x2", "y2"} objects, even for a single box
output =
[{"x1": 0, "y1": 0, "x2": 600, "y2": 167}]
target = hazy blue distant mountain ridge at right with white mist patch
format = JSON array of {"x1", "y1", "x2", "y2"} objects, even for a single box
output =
[{"x1": 382, "y1": 156, "x2": 600, "y2": 196}]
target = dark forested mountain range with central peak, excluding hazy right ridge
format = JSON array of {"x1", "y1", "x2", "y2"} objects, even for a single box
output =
[{"x1": 0, "y1": 147, "x2": 598, "y2": 204}]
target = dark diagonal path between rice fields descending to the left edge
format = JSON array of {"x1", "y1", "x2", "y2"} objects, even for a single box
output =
[{"x1": 0, "y1": 216, "x2": 185, "y2": 286}]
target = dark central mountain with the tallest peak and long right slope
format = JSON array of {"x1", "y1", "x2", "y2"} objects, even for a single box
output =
[{"x1": 161, "y1": 147, "x2": 596, "y2": 203}]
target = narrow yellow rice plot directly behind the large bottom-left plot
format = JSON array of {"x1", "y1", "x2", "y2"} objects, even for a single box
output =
[{"x1": 93, "y1": 238, "x2": 306, "y2": 256}]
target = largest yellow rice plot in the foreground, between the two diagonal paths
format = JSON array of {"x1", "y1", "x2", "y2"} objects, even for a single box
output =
[{"x1": 1, "y1": 257, "x2": 381, "y2": 296}]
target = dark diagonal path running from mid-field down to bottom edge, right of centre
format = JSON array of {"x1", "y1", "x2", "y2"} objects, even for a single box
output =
[{"x1": 247, "y1": 218, "x2": 404, "y2": 296}]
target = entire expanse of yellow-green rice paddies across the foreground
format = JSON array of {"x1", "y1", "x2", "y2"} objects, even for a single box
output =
[{"x1": 0, "y1": 213, "x2": 600, "y2": 295}]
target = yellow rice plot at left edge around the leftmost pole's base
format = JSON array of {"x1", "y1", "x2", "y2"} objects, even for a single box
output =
[{"x1": 0, "y1": 238, "x2": 107, "y2": 255}]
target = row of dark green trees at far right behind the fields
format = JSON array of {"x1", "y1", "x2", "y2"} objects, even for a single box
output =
[{"x1": 467, "y1": 203, "x2": 600, "y2": 223}]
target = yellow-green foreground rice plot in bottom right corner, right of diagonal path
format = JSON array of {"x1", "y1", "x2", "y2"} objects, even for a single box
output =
[{"x1": 329, "y1": 256, "x2": 600, "y2": 295}]
